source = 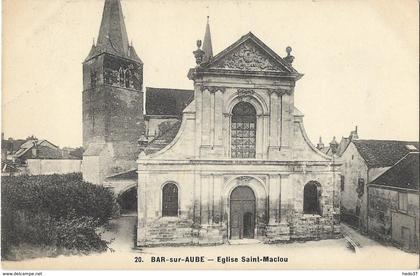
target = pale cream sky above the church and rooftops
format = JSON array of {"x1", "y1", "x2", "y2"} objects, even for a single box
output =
[{"x1": 1, "y1": 0, "x2": 419, "y2": 147}]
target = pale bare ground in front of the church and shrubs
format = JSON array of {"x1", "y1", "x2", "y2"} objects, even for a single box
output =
[{"x1": 2, "y1": 216, "x2": 419, "y2": 270}]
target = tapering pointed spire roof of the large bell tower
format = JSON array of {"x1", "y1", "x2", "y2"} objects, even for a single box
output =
[{"x1": 86, "y1": 0, "x2": 141, "y2": 63}]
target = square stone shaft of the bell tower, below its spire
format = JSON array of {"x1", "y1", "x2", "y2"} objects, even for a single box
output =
[{"x1": 82, "y1": 54, "x2": 145, "y2": 184}]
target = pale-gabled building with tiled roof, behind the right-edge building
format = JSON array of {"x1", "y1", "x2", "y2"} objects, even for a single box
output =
[{"x1": 337, "y1": 139, "x2": 419, "y2": 233}]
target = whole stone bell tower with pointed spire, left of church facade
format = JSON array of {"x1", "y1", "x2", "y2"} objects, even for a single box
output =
[{"x1": 83, "y1": 0, "x2": 145, "y2": 184}]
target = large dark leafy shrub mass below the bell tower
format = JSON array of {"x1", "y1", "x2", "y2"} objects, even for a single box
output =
[{"x1": 1, "y1": 174, "x2": 118, "y2": 258}]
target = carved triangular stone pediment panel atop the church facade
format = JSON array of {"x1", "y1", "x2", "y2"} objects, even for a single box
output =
[{"x1": 211, "y1": 40, "x2": 284, "y2": 72}]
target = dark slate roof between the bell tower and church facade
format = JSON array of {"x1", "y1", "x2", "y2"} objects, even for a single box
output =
[{"x1": 146, "y1": 87, "x2": 194, "y2": 116}]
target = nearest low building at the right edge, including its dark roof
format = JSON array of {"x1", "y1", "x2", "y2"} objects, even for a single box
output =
[{"x1": 368, "y1": 152, "x2": 419, "y2": 252}]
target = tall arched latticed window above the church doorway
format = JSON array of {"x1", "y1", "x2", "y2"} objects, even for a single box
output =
[{"x1": 231, "y1": 102, "x2": 257, "y2": 158}]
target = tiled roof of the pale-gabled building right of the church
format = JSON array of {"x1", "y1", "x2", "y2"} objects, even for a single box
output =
[{"x1": 352, "y1": 140, "x2": 419, "y2": 168}]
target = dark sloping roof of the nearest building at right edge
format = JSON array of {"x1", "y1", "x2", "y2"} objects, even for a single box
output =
[{"x1": 372, "y1": 152, "x2": 419, "y2": 190}]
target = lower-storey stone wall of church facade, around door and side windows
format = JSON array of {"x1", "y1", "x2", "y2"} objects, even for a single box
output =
[{"x1": 138, "y1": 161, "x2": 340, "y2": 246}]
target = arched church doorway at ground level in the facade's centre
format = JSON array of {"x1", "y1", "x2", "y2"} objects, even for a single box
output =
[{"x1": 230, "y1": 186, "x2": 255, "y2": 240}]
